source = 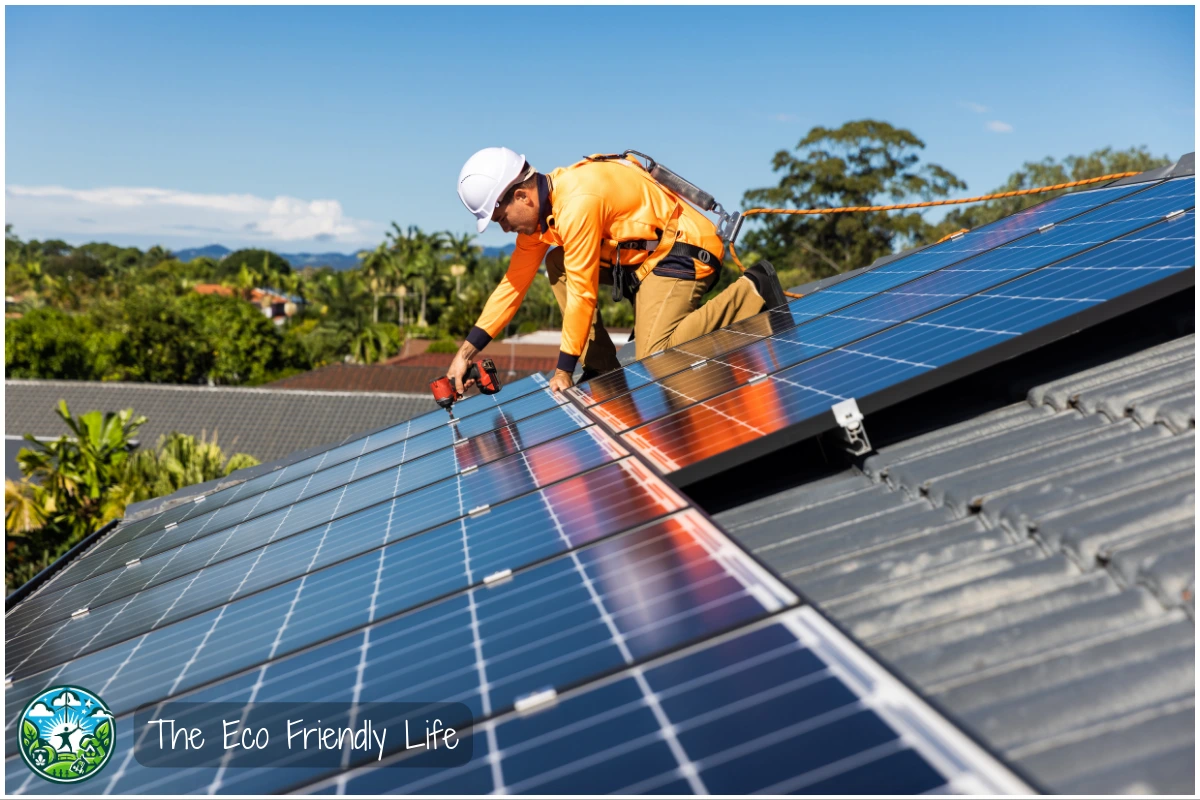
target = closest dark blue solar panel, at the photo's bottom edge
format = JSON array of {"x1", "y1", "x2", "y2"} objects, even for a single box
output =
[{"x1": 297, "y1": 608, "x2": 1024, "y2": 794}]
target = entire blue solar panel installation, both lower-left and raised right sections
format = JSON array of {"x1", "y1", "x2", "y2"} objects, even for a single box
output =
[{"x1": 5, "y1": 169, "x2": 1180, "y2": 794}]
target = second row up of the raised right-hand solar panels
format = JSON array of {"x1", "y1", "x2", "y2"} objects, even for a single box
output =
[{"x1": 580, "y1": 178, "x2": 1194, "y2": 432}]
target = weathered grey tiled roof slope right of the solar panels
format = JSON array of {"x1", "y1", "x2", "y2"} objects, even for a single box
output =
[{"x1": 716, "y1": 336, "x2": 1195, "y2": 794}]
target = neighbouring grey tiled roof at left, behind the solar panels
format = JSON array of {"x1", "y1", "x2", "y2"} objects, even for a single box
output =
[{"x1": 5, "y1": 380, "x2": 437, "y2": 461}]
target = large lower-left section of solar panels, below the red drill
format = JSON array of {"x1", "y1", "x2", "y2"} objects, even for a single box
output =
[{"x1": 5, "y1": 369, "x2": 1015, "y2": 794}]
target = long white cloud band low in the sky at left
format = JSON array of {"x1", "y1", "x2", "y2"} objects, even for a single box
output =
[{"x1": 5, "y1": 186, "x2": 383, "y2": 245}]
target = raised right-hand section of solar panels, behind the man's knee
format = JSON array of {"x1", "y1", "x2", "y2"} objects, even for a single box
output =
[{"x1": 572, "y1": 176, "x2": 1195, "y2": 486}]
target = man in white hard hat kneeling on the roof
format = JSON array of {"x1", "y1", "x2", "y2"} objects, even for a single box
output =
[{"x1": 446, "y1": 148, "x2": 785, "y2": 391}]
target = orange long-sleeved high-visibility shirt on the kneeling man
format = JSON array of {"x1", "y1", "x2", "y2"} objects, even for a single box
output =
[{"x1": 467, "y1": 161, "x2": 724, "y2": 372}]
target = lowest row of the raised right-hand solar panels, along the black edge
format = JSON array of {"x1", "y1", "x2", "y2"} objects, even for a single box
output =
[{"x1": 622, "y1": 203, "x2": 1195, "y2": 485}]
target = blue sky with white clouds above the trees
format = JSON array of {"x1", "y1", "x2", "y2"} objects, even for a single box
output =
[{"x1": 5, "y1": 6, "x2": 1195, "y2": 252}]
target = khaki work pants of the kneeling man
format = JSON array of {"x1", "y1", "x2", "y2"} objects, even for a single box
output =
[{"x1": 546, "y1": 247, "x2": 764, "y2": 373}]
